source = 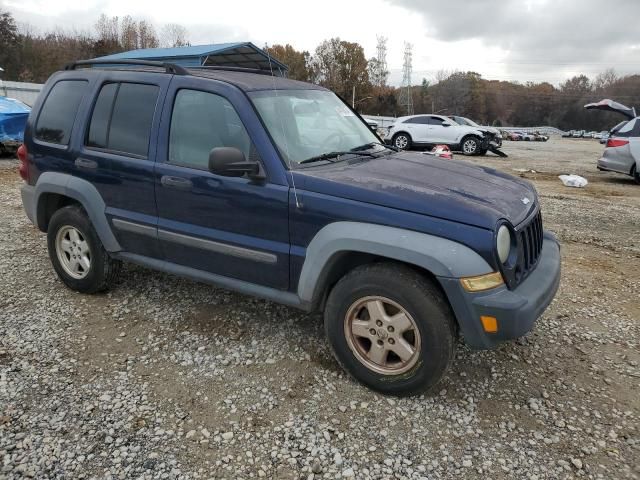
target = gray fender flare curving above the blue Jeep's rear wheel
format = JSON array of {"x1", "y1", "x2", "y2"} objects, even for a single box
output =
[{"x1": 34, "y1": 172, "x2": 122, "y2": 252}]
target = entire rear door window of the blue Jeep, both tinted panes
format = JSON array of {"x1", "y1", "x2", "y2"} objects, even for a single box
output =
[{"x1": 87, "y1": 83, "x2": 160, "y2": 157}]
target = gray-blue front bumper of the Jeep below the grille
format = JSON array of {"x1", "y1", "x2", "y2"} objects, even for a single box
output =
[{"x1": 438, "y1": 232, "x2": 560, "y2": 349}]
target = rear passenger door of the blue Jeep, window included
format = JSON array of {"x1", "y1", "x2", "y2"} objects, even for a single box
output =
[{"x1": 74, "y1": 70, "x2": 171, "y2": 258}]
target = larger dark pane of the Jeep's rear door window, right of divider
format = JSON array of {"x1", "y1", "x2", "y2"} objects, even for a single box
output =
[{"x1": 107, "y1": 83, "x2": 159, "y2": 157}]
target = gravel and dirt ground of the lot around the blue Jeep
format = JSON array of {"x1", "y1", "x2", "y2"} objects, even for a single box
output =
[{"x1": 0, "y1": 139, "x2": 640, "y2": 479}]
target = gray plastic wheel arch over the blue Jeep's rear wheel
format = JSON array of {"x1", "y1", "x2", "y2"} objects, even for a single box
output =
[{"x1": 34, "y1": 172, "x2": 122, "y2": 252}]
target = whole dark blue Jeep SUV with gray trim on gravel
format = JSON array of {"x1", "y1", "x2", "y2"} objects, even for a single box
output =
[{"x1": 18, "y1": 61, "x2": 560, "y2": 395}]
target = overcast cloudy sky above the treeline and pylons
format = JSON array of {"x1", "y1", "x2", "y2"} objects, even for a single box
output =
[{"x1": 5, "y1": 0, "x2": 640, "y2": 84}]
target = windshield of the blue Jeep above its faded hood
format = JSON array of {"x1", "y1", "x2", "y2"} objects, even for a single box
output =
[{"x1": 249, "y1": 90, "x2": 383, "y2": 165}]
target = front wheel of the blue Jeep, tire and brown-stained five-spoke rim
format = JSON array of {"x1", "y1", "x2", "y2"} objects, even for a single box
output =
[{"x1": 324, "y1": 263, "x2": 456, "y2": 396}]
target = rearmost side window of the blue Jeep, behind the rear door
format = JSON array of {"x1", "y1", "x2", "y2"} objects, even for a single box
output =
[{"x1": 35, "y1": 80, "x2": 88, "y2": 145}]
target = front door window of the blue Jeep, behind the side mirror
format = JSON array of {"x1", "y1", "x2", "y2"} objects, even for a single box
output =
[{"x1": 169, "y1": 90, "x2": 251, "y2": 170}]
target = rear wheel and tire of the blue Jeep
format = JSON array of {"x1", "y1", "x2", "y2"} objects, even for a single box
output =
[{"x1": 47, "y1": 205, "x2": 122, "y2": 293}]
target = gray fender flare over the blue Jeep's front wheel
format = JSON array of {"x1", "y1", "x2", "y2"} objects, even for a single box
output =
[{"x1": 298, "y1": 222, "x2": 493, "y2": 302}]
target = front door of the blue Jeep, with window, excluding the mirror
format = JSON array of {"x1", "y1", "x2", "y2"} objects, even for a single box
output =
[{"x1": 155, "y1": 77, "x2": 289, "y2": 290}]
